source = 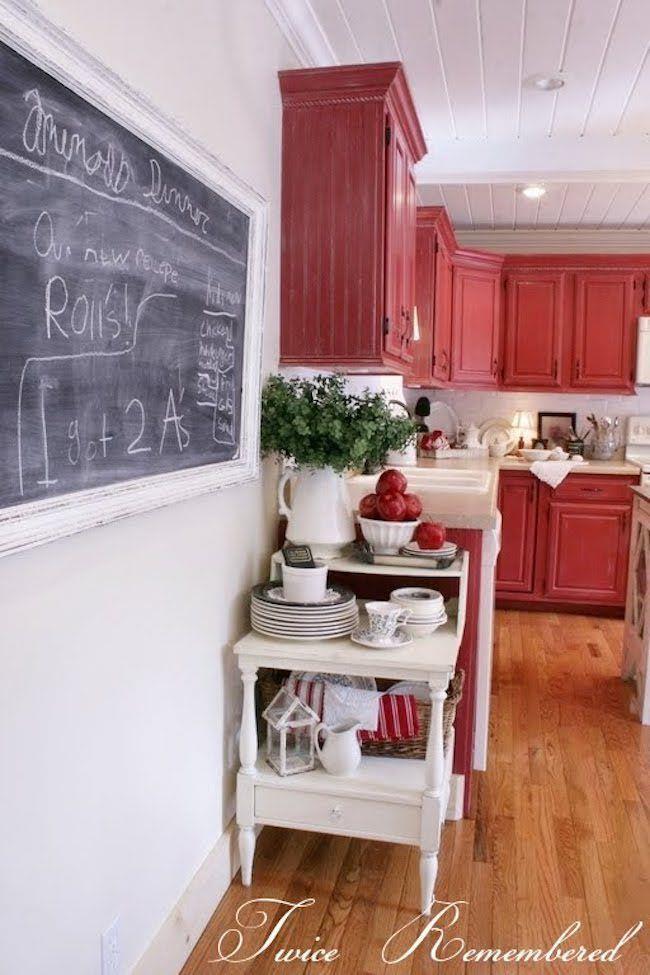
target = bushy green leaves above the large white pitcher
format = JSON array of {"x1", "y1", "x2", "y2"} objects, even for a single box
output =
[{"x1": 261, "y1": 376, "x2": 415, "y2": 472}]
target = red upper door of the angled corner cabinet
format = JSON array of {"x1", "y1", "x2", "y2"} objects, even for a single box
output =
[{"x1": 451, "y1": 267, "x2": 500, "y2": 387}]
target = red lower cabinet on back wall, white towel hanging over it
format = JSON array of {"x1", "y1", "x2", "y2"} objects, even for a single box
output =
[{"x1": 496, "y1": 471, "x2": 638, "y2": 611}]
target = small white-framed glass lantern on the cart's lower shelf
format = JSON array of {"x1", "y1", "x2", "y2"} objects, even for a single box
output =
[{"x1": 262, "y1": 687, "x2": 319, "y2": 775}]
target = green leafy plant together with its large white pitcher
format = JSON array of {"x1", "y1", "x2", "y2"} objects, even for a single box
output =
[{"x1": 261, "y1": 376, "x2": 414, "y2": 556}]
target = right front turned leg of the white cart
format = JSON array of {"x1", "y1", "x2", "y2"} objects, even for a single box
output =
[{"x1": 420, "y1": 682, "x2": 447, "y2": 915}]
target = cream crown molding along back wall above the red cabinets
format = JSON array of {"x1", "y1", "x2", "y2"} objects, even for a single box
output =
[{"x1": 456, "y1": 227, "x2": 650, "y2": 254}]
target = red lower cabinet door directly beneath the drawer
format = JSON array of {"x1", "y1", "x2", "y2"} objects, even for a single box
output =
[{"x1": 544, "y1": 500, "x2": 630, "y2": 605}]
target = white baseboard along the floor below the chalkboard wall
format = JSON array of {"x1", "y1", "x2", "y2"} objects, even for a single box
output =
[{"x1": 131, "y1": 820, "x2": 239, "y2": 975}]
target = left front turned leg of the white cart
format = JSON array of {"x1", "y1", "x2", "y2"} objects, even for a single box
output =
[{"x1": 237, "y1": 660, "x2": 257, "y2": 887}]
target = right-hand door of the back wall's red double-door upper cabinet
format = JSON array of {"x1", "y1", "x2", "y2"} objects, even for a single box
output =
[{"x1": 571, "y1": 271, "x2": 642, "y2": 392}]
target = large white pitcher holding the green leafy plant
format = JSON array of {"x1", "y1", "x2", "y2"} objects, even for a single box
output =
[{"x1": 278, "y1": 467, "x2": 356, "y2": 559}]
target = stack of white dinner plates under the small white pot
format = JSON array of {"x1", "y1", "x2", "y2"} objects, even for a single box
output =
[{"x1": 251, "y1": 582, "x2": 359, "y2": 641}]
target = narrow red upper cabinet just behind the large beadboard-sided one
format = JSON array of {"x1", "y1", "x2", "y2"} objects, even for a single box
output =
[{"x1": 406, "y1": 207, "x2": 455, "y2": 386}]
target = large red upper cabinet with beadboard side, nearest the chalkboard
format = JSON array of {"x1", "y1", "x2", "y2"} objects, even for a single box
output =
[{"x1": 279, "y1": 63, "x2": 425, "y2": 372}]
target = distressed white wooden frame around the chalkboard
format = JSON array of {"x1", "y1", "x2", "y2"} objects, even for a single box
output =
[{"x1": 0, "y1": 0, "x2": 268, "y2": 556}]
